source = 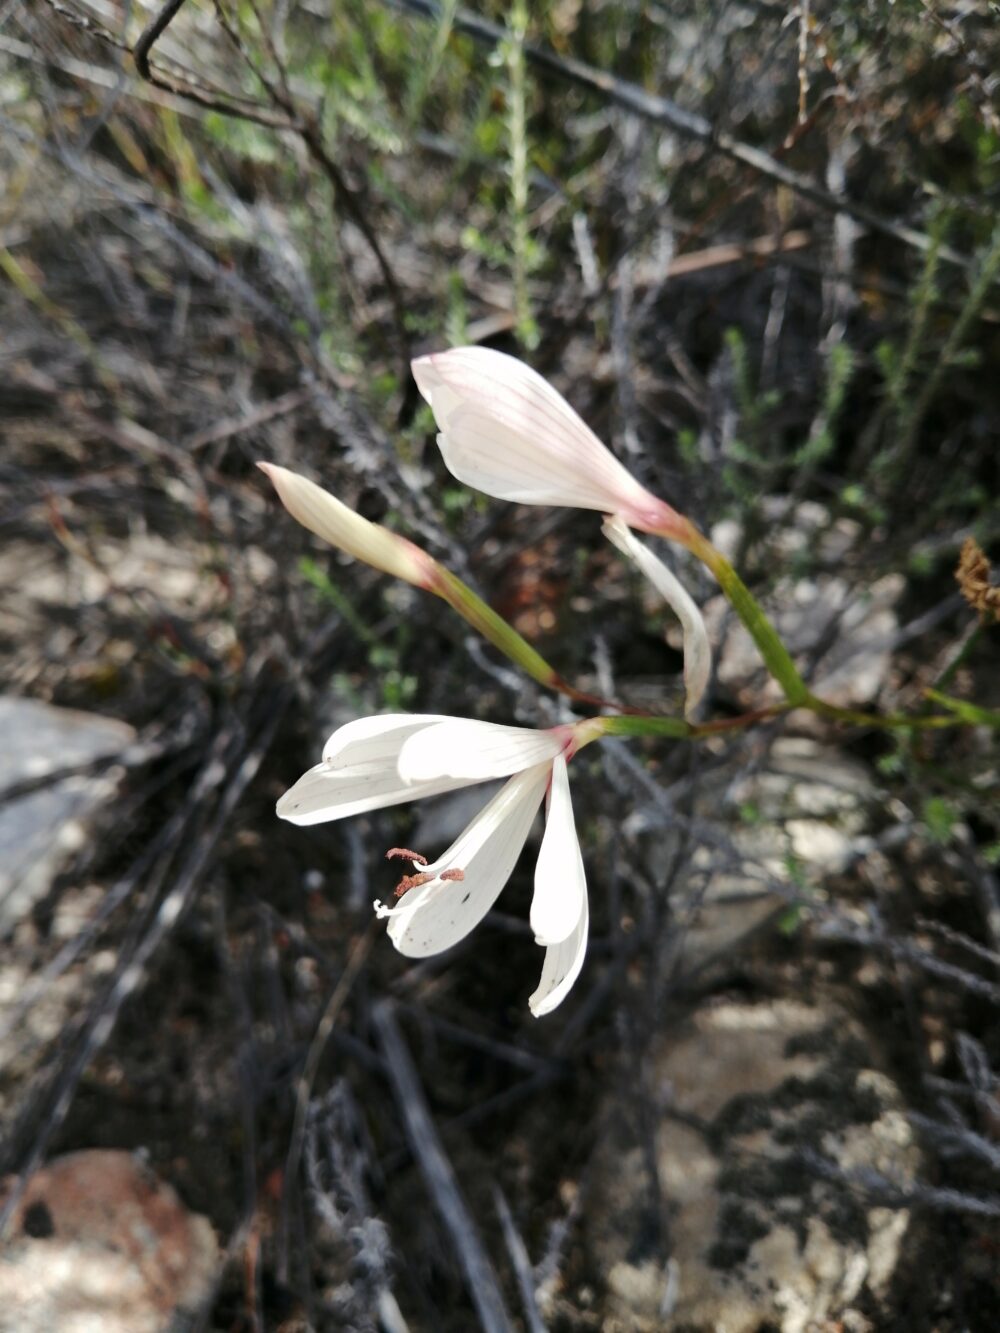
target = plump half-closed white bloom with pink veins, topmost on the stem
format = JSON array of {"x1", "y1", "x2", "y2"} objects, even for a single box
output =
[{"x1": 412, "y1": 347, "x2": 684, "y2": 536}]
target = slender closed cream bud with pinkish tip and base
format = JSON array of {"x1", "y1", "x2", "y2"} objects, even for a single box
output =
[{"x1": 257, "y1": 463, "x2": 435, "y2": 588}]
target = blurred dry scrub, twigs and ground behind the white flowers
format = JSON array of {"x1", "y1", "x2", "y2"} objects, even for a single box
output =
[{"x1": 0, "y1": 0, "x2": 1000, "y2": 1330}]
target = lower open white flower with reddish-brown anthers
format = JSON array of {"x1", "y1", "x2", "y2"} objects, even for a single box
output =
[{"x1": 277, "y1": 713, "x2": 600, "y2": 1016}]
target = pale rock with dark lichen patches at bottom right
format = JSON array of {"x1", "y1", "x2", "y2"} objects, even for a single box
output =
[{"x1": 584, "y1": 1000, "x2": 920, "y2": 1333}]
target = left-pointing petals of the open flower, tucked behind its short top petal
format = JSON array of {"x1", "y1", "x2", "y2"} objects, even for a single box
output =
[{"x1": 277, "y1": 713, "x2": 468, "y2": 824}]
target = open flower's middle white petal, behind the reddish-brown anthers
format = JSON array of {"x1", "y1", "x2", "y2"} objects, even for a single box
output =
[{"x1": 389, "y1": 764, "x2": 549, "y2": 958}]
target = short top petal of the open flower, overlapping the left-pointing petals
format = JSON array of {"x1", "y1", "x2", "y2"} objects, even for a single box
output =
[{"x1": 399, "y1": 717, "x2": 567, "y2": 782}]
